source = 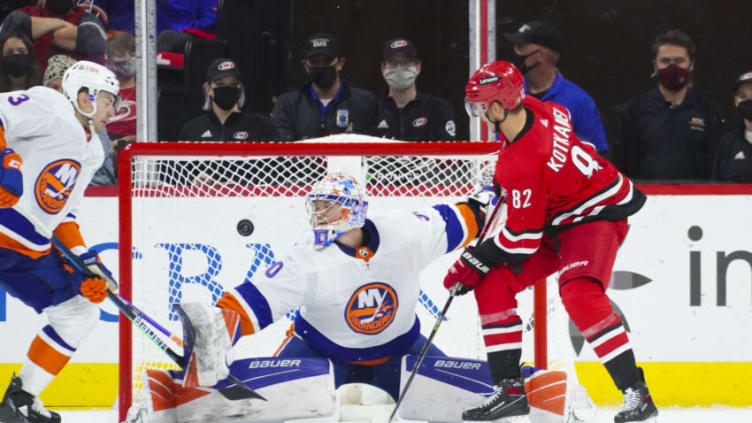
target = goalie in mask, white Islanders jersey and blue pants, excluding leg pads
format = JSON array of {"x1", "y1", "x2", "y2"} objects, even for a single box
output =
[{"x1": 185, "y1": 174, "x2": 485, "y2": 400}]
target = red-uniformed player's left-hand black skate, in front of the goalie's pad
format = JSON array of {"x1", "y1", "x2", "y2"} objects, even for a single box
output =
[{"x1": 462, "y1": 377, "x2": 530, "y2": 421}]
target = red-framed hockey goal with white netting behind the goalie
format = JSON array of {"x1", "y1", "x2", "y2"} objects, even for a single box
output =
[{"x1": 119, "y1": 140, "x2": 548, "y2": 420}]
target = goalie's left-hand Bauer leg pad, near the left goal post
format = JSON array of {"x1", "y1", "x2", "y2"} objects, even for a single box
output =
[{"x1": 131, "y1": 357, "x2": 337, "y2": 423}]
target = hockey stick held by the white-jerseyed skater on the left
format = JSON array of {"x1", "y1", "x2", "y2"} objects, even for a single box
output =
[{"x1": 50, "y1": 235, "x2": 266, "y2": 401}]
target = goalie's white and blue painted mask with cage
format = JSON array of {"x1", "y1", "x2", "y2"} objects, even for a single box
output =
[{"x1": 306, "y1": 173, "x2": 368, "y2": 249}]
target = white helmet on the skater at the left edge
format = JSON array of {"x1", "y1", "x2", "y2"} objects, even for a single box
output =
[{"x1": 63, "y1": 60, "x2": 120, "y2": 118}]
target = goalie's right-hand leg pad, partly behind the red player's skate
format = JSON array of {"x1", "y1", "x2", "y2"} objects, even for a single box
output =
[{"x1": 399, "y1": 355, "x2": 592, "y2": 423}]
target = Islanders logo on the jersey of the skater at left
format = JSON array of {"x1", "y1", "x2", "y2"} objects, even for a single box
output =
[{"x1": 34, "y1": 159, "x2": 81, "y2": 214}]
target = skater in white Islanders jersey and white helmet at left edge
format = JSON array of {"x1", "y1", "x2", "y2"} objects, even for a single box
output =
[{"x1": 0, "y1": 61, "x2": 118, "y2": 423}]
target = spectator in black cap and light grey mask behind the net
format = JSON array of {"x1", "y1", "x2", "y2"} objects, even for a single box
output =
[{"x1": 376, "y1": 38, "x2": 456, "y2": 141}]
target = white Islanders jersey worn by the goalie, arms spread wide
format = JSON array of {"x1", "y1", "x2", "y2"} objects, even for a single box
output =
[{"x1": 227, "y1": 204, "x2": 478, "y2": 362}]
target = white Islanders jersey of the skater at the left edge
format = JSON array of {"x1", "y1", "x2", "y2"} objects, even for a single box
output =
[{"x1": 0, "y1": 87, "x2": 104, "y2": 258}]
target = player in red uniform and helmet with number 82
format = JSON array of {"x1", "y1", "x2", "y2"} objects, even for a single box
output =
[{"x1": 444, "y1": 62, "x2": 658, "y2": 423}]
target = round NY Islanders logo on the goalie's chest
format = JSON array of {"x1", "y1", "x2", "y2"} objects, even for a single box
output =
[{"x1": 345, "y1": 282, "x2": 397, "y2": 335}]
